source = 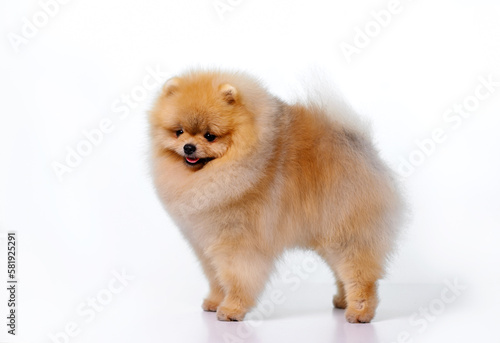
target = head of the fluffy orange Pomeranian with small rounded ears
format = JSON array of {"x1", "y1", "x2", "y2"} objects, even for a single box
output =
[{"x1": 151, "y1": 72, "x2": 256, "y2": 171}]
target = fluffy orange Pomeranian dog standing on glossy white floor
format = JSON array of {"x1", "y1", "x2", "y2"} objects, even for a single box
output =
[{"x1": 150, "y1": 71, "x2": 401, "y2": 323}]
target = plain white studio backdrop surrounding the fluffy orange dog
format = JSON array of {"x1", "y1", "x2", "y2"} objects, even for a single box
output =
[{"x1": 0, "y1": 0, "x2": 500, "y2": 343}]
